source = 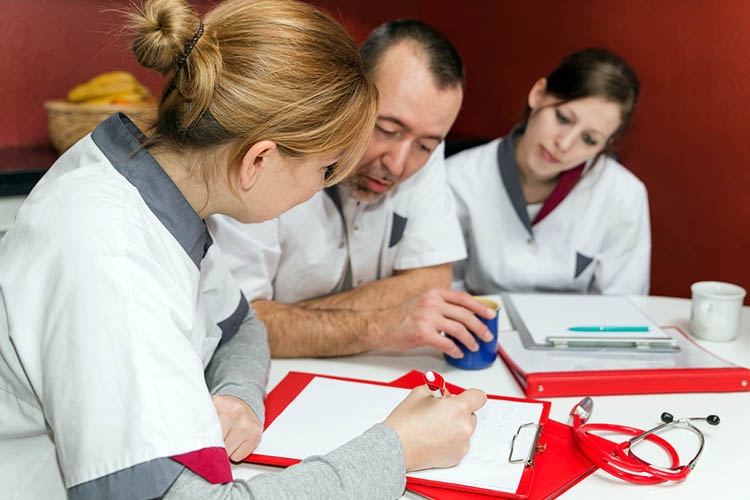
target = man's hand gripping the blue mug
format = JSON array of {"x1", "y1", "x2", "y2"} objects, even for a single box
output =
[{"x1": 382, "y1": 288, "x2": 495, "y2": 358}]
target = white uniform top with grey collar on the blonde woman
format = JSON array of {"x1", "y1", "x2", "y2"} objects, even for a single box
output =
[{"x1": 0, "y1": 115, "x2": 241, "y2": 499}]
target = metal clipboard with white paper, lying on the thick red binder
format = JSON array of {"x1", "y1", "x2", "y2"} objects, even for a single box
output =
[{"x1": 502, "y1": 293, "x2": 679, "y2": 352}]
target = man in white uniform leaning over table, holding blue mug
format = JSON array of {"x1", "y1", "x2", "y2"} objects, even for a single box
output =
[{"x1": 209, "y1": 21, "x2": 494, "y2": 357}]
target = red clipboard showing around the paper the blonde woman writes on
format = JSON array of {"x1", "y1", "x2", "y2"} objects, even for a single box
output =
[{"x1": 244, "y1": 371, "x2": 551, "y2": 500}]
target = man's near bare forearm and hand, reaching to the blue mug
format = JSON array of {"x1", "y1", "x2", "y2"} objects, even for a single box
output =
[{"x1": 252, "y1": 288, "x2": 495, "y2": 358}]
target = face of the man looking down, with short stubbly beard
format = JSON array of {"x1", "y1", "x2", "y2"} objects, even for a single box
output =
[{"x1": 342, "y1": 42, "x2": 463, "y2": 202}]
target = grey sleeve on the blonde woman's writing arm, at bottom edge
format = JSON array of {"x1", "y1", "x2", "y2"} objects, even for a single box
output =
[{"x1": 164, "y1": 424, "x2": 406, "y2": 500}]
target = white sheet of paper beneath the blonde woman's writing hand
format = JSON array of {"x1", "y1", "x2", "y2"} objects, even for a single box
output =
[{"x1": 254, "y1": 377, "x2": 543, "y2": 493}]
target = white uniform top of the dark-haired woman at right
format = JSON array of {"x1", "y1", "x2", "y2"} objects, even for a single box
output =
[{"x1": 447, "y1": 133, "x2": 651, "y2": 295}]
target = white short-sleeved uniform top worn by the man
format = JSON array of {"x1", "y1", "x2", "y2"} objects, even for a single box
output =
[{"x1": 207, "y1": 143, "x2": 466, "y2": 303}]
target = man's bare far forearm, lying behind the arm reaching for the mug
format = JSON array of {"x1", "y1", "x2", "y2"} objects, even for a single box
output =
[{"x1": 297, "y1": 263, "x2": 451, "y2": 311}]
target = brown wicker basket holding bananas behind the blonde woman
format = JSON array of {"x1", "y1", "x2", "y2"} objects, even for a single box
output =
[{"x1": 44, "y1": 101, "x2": 157, "y2": 153}]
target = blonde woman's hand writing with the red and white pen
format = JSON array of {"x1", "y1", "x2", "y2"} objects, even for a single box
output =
[{"x1": 383, "y1": 385, "x2": 487, "y2": 471}]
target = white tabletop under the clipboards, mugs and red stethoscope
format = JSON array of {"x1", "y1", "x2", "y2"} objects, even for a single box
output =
[{"x1": 232, "y1": 297, "x2": 750, "y2": 500}]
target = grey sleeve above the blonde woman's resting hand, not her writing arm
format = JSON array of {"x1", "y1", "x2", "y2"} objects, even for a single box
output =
[{"x1": 205, "y1": 307, "x2": 271, "y2": 423}]
